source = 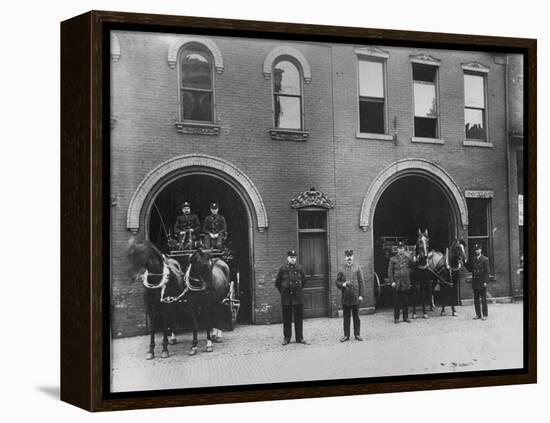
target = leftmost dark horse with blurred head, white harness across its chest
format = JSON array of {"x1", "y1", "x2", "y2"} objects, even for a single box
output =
[{"x1": 127, "y1": 237, "x2": 185, "y2": 360}]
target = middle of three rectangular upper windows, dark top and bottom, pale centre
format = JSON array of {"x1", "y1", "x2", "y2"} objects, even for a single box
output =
[{"x1": 412, "y1": 63, "x2": 439, "y2": 138}]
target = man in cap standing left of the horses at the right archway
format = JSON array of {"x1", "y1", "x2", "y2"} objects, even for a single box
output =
[{"x1": 388, "y1": 241, "x2": 413, "y2": 323}]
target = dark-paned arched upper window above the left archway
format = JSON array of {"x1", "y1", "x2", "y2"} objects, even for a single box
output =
[{"x1": 179, "y1": 44, "x2": 215, "y2": 123}]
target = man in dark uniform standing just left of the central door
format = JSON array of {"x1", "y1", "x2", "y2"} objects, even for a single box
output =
[{"x1": 275, "y1": 250, "x2": 306, "y2": 345}]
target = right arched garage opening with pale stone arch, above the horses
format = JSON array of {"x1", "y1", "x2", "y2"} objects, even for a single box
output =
[{"x1": 359, "y1": 159, "x2": 468, "y2": 306}]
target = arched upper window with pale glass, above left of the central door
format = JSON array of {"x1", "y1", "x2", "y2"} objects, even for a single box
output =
[{"x1": 273, "y1": 58, "x2": 303, "y2": 130}]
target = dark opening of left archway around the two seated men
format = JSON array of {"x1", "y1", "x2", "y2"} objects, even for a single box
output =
[{"x1": 145, "y1": 171, "x2": 253, "y2": 323}]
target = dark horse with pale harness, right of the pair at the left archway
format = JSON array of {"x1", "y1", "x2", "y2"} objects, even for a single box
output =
[{"x1": 184, "y1": 248, "x2": 230, "y2": 355}]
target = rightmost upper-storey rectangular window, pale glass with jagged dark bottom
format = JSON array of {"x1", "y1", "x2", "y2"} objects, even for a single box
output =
[{"x1": 464, "y1": 72, "x2": 487, "y2": 141}]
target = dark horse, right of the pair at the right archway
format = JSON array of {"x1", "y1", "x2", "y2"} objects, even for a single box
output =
[{"x1": 428, "y1": 238, "x2": 466, "y2": 316}]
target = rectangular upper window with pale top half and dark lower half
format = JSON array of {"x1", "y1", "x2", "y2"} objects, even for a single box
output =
[{"x1": 359, "y1": 59, "x2": 386, "y2": 134}]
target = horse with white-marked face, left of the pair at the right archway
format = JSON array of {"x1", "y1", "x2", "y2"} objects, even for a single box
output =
[{"x1": 412, "y1": 228, "x2": 433, "y2": 319}]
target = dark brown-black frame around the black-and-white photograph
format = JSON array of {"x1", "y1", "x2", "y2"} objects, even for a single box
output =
[{"x1": 61, "y1": 11, "x2": 537, "y2": 411}]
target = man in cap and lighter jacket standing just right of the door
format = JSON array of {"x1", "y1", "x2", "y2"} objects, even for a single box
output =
[{"x1": 336, "y1": 250, "x2": 363, "y2": 342}]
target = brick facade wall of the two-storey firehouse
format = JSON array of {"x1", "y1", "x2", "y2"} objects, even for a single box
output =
[{"x1": 111, "y1": 32, "x2": 510, "y2": 336}]
